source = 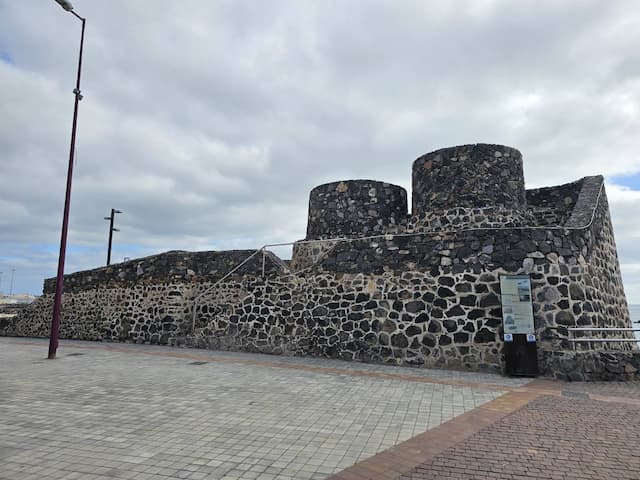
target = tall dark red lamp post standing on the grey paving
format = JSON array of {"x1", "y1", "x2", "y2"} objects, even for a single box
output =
[{"x1": 49, "y1": 0, "x2": 86, "y2": 359}]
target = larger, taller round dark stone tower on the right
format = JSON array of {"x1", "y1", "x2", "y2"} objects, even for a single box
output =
[{"x1": 412, "y1": 143, "x2": 529, "y2": 230}]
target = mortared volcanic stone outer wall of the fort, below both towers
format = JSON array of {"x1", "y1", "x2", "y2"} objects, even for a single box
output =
[{"x1": 9, "y1": 178, "x2": 628, "y2": 375}]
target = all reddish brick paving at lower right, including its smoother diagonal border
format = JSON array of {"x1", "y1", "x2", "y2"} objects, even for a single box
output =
[{"x1": 331, "y1": 380, "x2": 640, "y2": 480}]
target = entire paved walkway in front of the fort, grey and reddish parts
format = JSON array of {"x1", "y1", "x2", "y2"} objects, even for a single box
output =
[{"x1": 0, "y1": 338, "x2": 640, "y2": 480}]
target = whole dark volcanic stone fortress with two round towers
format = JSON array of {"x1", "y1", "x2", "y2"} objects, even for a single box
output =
[{"x1": 0, "y1": 144, "x2": 640, "y2": 379}]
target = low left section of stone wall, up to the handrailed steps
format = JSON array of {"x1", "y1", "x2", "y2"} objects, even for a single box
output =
[{"x1": 8, "y1": 250, "x2": 286, "y2": 344}]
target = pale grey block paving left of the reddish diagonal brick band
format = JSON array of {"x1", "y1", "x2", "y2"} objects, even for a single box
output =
[{"x1": 0, "y1": 338, "x2": 524, "y2": 480}]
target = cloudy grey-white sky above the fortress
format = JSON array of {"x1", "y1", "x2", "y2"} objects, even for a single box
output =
[{"x1": 0, "y1": 0, "x2": 640, "y2": 303}]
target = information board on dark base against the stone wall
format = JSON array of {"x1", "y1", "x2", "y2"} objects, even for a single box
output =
[{"x1": 500, "y1": 275, "x2": 538, "y2": 376}]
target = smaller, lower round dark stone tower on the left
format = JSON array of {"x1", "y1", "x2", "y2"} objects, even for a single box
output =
[{"x1": 307, "y1": 180, "x2": 407, "y2": 240}]
